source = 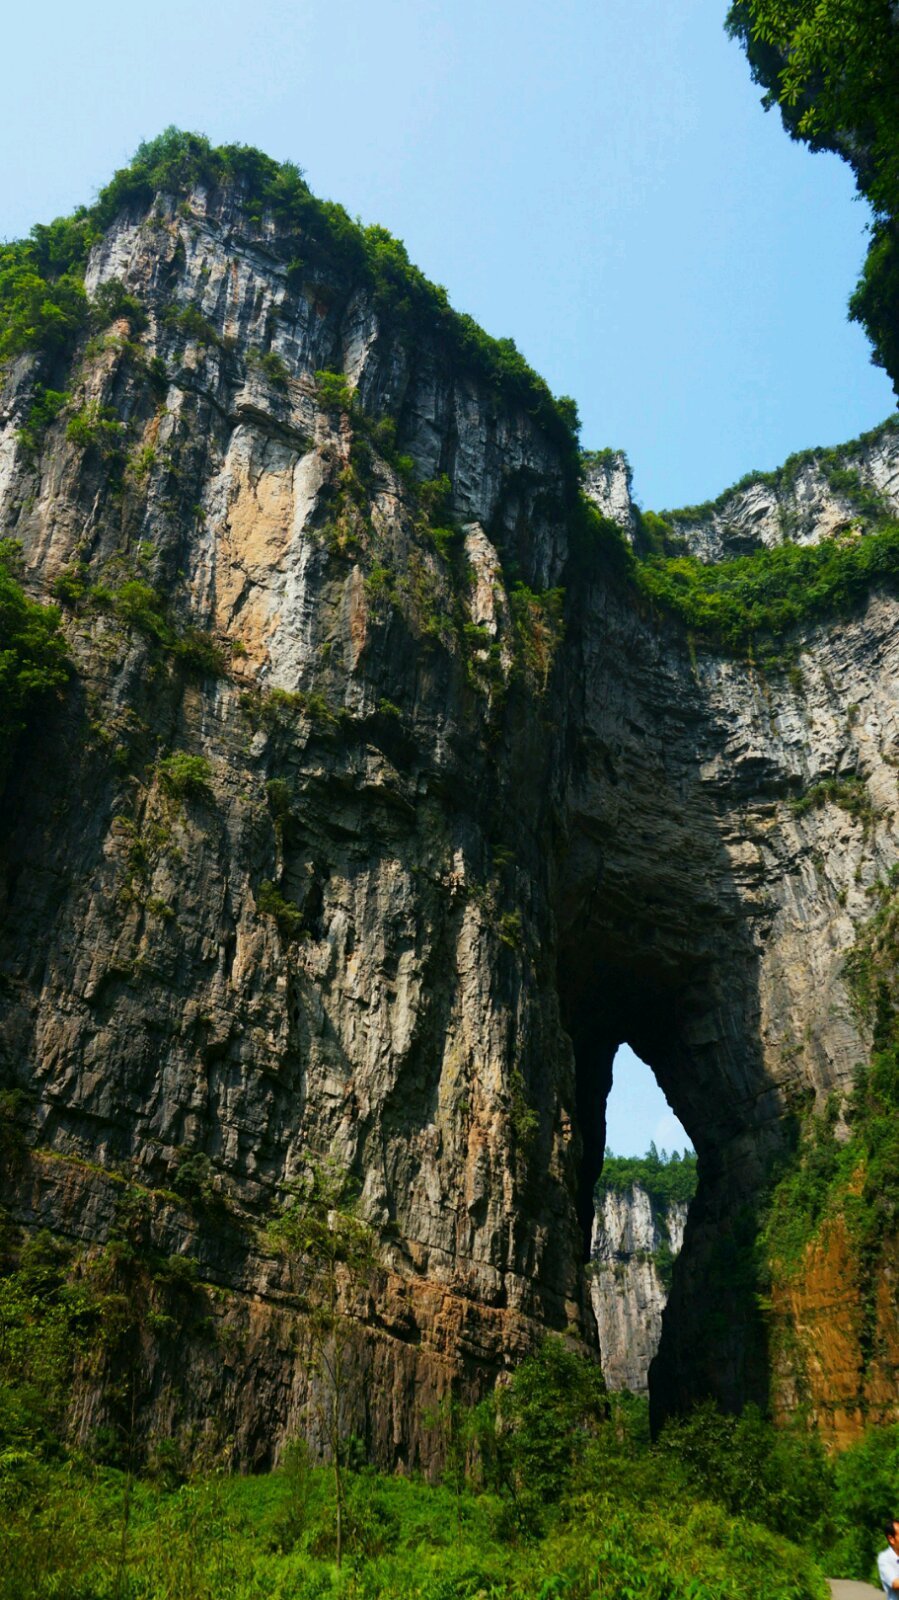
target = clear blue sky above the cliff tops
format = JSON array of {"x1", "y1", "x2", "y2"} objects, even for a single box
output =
[{"x1": 0, "y1": 0, "x2": 894, "y2": 507}]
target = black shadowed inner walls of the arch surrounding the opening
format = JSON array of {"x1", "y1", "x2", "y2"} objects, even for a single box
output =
[{"x1": 558, "y1": 923, "x2": 776, "y2": 1426}]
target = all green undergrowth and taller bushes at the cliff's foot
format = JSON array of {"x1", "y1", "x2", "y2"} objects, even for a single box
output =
[{"x1": 0, "y1": 1254, "x2": 830, "y2": 1600}]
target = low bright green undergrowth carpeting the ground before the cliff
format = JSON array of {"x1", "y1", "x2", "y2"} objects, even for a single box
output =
[{"x1": 0, "y1": 1464, "x2": 827, "y2": 1600}]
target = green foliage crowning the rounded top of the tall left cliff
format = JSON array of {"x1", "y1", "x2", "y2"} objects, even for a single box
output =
[{"x1": 0, "y1": 128, "x2": 577, "y2": 467}]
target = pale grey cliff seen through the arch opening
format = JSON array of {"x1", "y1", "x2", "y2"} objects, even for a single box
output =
[{"x1": 589, "y1": 1184, "x2": 688, "y2": 1395}]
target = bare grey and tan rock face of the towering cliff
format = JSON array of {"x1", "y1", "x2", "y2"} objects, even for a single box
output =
[{"x1": 0, "y1": 181, "x2": 899, "y2": 1464}]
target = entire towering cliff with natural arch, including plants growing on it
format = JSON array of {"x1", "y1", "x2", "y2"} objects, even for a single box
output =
[{"x1": 0, "y1": 5, "x2": 899, "y2": 1597}]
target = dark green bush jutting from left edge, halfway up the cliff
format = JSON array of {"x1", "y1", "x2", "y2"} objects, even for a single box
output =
[{"x1": 0, "y1": 539, "x2": 69, "y2": 784}]
